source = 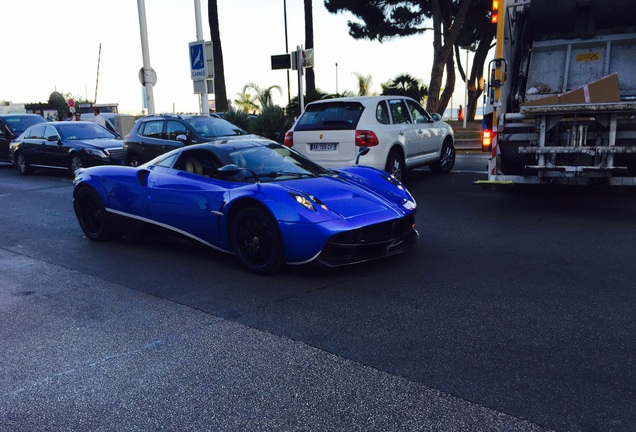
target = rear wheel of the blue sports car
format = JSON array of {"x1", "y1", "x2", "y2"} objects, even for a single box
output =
[{"x1": 73, "y1": 186, "x2": 113, "y2": 242}]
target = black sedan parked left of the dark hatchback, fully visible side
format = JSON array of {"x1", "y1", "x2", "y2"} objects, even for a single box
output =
[{"x1": 9, "y1": 121, "x2": 124, "y2": 175}]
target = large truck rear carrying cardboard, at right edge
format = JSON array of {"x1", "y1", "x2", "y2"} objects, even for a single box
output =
[{"x1": 480, "y1": 0, "x2": 636, "y2": 186}]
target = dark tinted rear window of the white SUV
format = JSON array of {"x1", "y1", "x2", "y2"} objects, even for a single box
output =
[{"x1": 294, "y1": 102, "x2": 364, "y2": 131}]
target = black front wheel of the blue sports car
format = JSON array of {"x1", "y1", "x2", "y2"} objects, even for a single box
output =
[{"x1": 230, "y1": 206, "x2": 283, "y2": 275}]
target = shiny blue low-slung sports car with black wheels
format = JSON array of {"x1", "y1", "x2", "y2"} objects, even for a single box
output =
[{"x1": 73, "y1": 138, "x2": 418, "y2": 274}]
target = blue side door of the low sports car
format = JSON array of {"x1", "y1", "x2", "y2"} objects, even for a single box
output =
[{"x1": 148, "y1": 150, "x2": 227, "y2": 245}]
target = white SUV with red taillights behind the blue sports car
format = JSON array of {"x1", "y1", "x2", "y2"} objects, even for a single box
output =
[{"x1": 285, "y1": 96, "x2": 455, "y2": 180}]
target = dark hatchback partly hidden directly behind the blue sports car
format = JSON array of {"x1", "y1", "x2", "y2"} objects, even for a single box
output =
[{"x1": 124, "y1": 114, "x2": 248, "y2": 166}]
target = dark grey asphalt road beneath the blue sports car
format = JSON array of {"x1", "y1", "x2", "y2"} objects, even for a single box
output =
[{"x1": 0, "y1": 154, "x2": 636, "y2": 431}]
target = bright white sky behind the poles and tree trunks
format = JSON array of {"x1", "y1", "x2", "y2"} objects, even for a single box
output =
[{"x1": 0, "y1": 0, "x2": 463, "y2": 114}]
